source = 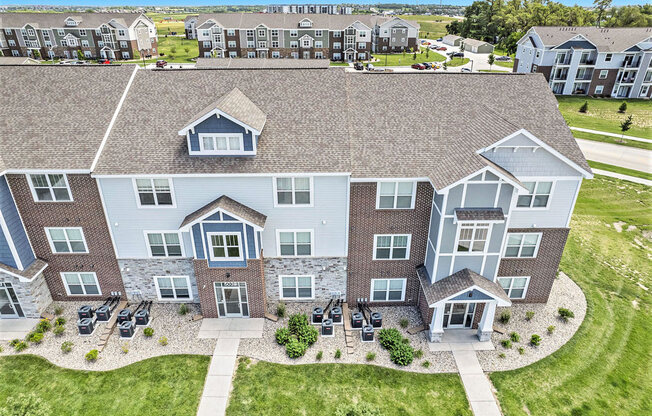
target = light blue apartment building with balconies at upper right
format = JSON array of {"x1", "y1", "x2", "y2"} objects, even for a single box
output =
[{"x1": 514, "y1": 26, "x2": 652, "y2": 98}]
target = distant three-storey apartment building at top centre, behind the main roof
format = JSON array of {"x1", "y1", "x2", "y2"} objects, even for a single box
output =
[{"x1": 186, "y1": 13, "x2": 419, "y2": 61}]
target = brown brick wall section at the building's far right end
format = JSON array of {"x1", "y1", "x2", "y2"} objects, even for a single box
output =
[{"x1": 498, "y1": 228, "x2": 570, "y2": 303}]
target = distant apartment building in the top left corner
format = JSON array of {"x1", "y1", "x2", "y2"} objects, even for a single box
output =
[{"x1": 0, "y1": 13, "x2": 158, "y2": 59}]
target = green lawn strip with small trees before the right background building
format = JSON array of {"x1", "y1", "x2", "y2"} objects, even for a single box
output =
[{"x1": 557, "y1": 96, "x2": 652, "y2": 139}]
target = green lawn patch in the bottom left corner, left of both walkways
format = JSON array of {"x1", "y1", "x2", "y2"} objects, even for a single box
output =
[{"x1": 0, "y1": 354, "x2": 210, "y2": 416}]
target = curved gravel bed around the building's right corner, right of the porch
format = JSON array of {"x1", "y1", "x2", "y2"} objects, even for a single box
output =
[{"x1": 478, "y1": 272, "x2": 586, "y2": 371}]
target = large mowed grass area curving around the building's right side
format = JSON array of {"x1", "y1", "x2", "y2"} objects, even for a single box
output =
[{"x1": 490, "y1": 175, "x2": 652, "y2": 416}]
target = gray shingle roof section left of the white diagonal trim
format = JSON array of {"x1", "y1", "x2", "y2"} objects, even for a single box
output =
[{"x1": 0, "y1": 65, "x2": 134, "y2": 172}]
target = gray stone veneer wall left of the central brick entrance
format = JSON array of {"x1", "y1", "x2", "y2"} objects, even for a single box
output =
[{"x1": 118, "y1": 258, "x2": 199, "y2": 303}]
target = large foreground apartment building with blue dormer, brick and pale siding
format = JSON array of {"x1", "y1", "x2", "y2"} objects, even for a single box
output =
[{"x1": 0, "y1": 66, "x2": 592, "y2": 341}]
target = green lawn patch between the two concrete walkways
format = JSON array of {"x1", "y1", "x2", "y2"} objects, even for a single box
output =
[{"x1": 226, "y1": 358, "x2": 471, "y2": 416}]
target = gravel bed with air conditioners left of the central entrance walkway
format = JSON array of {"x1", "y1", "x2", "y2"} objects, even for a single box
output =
[{"x1": 1, "y1": 302, "x2": 216, "y2": 370}]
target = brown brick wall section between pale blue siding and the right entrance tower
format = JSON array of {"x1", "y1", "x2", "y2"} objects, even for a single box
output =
[{"x1": 347, "y1": 182, "x2": 433, "y2": 305}]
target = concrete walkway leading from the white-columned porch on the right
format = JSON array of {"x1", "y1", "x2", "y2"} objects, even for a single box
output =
[{"x1": 453, "y1": 350, "x2": 502, "y2": 416}]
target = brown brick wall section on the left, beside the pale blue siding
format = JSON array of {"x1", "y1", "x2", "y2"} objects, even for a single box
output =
[{"x1": 7, "y1": 174, "x2": 125, "y2": 301}]
